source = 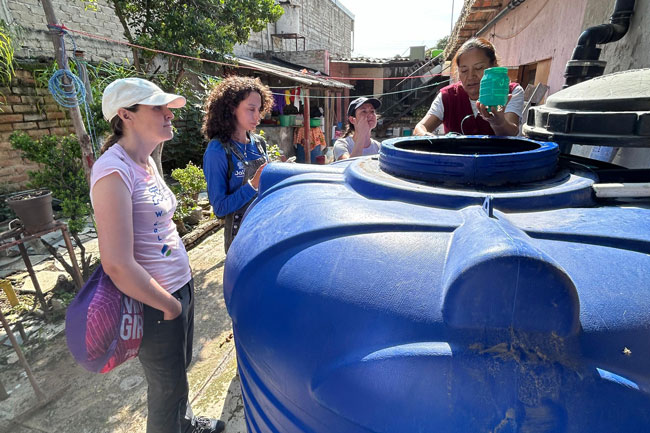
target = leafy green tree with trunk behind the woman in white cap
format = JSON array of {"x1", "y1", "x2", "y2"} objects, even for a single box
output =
[{"x1": 105, "y1": 0, "x2": 283, "y2": 174}]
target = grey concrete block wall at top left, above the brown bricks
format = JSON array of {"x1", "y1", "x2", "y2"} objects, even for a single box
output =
[{"x1": 6, "y1": 0, "x2": 133, "y2": 63}]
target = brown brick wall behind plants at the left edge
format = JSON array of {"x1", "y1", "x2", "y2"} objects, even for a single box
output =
[{"x1": 0, "y1": 70, "x2": 74, "y2": 191}]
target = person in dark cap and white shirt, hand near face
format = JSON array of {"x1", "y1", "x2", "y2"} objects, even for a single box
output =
[{"x1": 334, "y1": 97, "x2": 381, "y2": 161}]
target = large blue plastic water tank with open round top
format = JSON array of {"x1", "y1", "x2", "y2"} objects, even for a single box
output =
[{"x1": 224, "y1": 137, "x2": 650, "y2": 433}]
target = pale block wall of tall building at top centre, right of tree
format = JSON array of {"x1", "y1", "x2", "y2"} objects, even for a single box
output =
[{"x1": 234, "y1": 0, "x2": 354, "y2": 58}]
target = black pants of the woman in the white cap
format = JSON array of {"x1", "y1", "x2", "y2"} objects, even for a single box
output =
[{"x1": 138, "y1": 280, "x2": 194, "y2": 433}]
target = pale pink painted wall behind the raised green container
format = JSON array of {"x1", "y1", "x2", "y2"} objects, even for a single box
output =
[{"x1": 483, "y1": 0, "x2": 588, "y2": 94}]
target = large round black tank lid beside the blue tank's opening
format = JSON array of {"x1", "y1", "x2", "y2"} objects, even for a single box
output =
[{"x1": 523, "y1": 69, "x2": 650, "y2": 147}]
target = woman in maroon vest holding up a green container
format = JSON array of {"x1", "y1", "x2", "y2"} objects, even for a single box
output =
[{"x1": 414, "y1": 38, "x2": 524, "y2": 135}]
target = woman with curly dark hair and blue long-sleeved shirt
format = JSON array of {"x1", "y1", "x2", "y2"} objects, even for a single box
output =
[{"x1": 203, "y1": 77, "x2": 273, "y2": 253}]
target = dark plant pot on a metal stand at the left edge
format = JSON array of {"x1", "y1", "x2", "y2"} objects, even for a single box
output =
[{"x1": 6, "y1": 189, "x2": 54, "y2": 233}]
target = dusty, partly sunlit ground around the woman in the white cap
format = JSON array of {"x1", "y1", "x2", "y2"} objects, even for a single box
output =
[{"x1": 0, "y1": 230, "x2": 246, "y2": 433}]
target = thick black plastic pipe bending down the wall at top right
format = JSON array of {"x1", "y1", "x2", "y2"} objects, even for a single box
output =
[{"x1": 564, "y1": 0, "x2": 635, "y2": 87}]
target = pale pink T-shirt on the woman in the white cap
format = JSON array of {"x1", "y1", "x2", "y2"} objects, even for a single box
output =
[{"x1": 90, "y1": 144, "x2": 192, "y2": 293}]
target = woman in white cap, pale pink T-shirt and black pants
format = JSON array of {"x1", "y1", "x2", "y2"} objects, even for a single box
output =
[{"x1": 90, "y1": 78, "x2": 224, "y2": 433}]
